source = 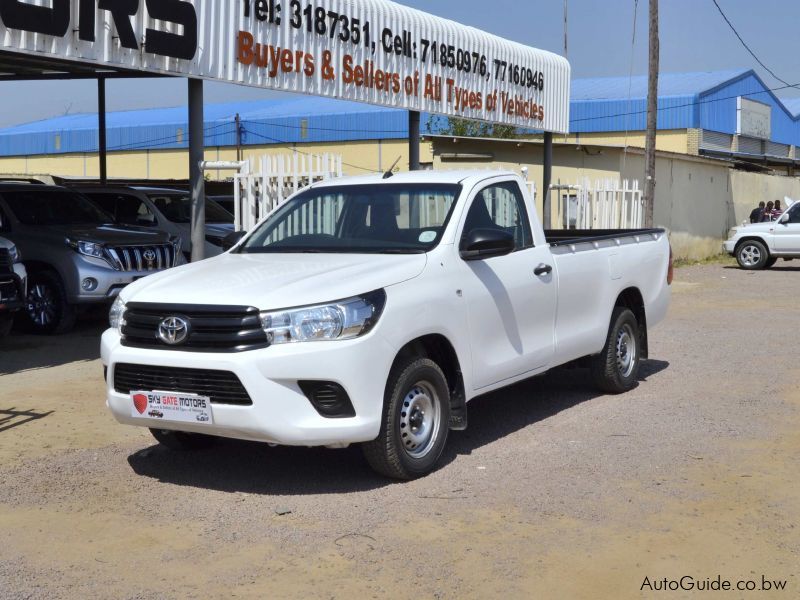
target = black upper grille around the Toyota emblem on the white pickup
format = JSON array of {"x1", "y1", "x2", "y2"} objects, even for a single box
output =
[{"x1": 122, "y1": 302, "x2": 269, "y2": 352}]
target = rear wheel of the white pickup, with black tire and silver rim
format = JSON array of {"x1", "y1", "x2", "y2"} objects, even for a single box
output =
[{"x1": 591, "y1": 306, "x2": 642, "y2": 394}]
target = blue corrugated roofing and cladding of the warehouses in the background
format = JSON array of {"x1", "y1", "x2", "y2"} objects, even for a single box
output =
[{"x1": 0, "y1": 69, "x2": 800, "y2": 156}]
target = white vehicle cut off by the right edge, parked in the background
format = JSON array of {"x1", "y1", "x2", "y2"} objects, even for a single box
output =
[{"x1": 722, "y1": 198, "x2": 800, "y2": 271}]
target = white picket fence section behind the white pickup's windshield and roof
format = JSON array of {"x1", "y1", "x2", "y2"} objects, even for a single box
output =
[{"x1": 233, "y1": 152, "x2": 342, "y2": 231}]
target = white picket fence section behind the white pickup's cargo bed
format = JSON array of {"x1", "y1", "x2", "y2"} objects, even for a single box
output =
[{"x1": 550, "y1": 179, "x2": 644, "y2": 229}]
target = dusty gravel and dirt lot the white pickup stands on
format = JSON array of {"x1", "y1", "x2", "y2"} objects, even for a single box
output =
[{"x1": 0, "y1": 263, "x2": 800, "y2": 599}]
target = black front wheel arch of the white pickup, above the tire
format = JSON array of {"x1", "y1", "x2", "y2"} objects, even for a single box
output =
[{"x1": 392, "y1": 333, "x2": 467, "y2": 429}]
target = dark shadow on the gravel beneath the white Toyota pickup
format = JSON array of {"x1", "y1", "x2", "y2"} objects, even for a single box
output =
[{"x1": 128, "y1": 360, "x2": 669, "y2": 495}]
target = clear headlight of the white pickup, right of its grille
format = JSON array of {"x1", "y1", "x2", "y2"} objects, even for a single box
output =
[{"x1": 261, "y1": 290, "x2": 386, "y2": 344}]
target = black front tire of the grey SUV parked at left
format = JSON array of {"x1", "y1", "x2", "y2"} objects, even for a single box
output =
[{"x1": 25, "y1": 271, "x2": 78, "y2": 335}]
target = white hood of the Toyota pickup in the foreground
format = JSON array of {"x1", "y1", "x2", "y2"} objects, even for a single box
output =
[{"x1": 121, "y1": 254, "x2": 427, "y2": 310}]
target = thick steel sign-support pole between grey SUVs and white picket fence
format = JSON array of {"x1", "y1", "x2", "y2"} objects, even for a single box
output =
[{"x1": 189, "y1": 79, "x2": 206, "y2": 262}]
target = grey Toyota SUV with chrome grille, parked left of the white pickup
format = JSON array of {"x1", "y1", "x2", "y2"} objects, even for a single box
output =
[{"x1": 0, "y1": 184, "x2": 184, "y2": 333}]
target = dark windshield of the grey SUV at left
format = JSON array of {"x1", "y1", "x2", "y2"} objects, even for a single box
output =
[{"x1": 3, "y1": 187, "x2": 114, "y2": 225}]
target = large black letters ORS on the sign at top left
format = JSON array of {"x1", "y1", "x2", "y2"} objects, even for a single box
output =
[{"x1": 0, "y1": 0, "x2": 197, "y2": 60}]
